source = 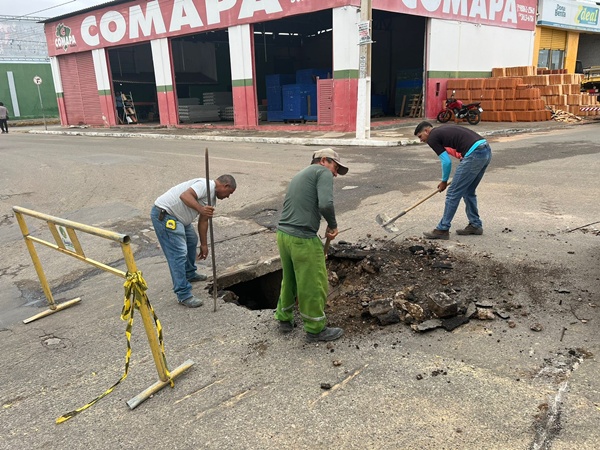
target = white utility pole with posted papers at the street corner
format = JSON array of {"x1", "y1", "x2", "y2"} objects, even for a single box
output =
[{"x1": 356, "y1": 0, "x2": 373, "y2": 139}]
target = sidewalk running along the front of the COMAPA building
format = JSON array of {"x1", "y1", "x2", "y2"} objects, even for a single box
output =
[{"x1": 12, "y1": 118, "x2": 598, "y2": 147}]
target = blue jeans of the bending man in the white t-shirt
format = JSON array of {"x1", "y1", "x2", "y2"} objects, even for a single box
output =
[{"x1": 150, "y1": 206, "x2": 198, "y2": 302}]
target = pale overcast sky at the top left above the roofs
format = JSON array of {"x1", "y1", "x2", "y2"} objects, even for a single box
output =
[{"x1": 9, "y1": 0, "x2": 110, "y2": 17}]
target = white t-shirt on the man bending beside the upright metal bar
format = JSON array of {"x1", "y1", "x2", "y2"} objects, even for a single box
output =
[{"x1": 154, "y1": 178, "x2": 217, "y2": 225}]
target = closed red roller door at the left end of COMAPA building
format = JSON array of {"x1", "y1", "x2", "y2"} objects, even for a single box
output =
[{"x1": 58, "y1": 52, "x2": 104, "y2": 125}]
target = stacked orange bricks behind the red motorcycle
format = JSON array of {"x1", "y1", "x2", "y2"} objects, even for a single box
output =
[{"x1": 446, "y1": 66, "x2": 600, "y2": 122}]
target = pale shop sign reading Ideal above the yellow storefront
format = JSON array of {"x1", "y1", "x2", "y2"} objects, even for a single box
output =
[{"x1": 538, "y1": 0, "x2": 600, "y2": 33}]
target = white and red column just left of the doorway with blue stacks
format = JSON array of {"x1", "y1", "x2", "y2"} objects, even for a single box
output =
[{"x1": 228, "y1": 24, "x2": 258, "y2": 128}]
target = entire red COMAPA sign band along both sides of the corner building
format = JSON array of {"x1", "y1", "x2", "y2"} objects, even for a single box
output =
[{"x1": 45, "y1": 0, "x2": 536, "y2": 56}]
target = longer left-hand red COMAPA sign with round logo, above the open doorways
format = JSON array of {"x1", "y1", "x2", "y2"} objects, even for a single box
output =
[{"x1": 45, "y1": 0, "x2": 350, "y2": 56}]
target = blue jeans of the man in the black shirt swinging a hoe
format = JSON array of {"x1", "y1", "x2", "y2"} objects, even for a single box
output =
[{"x1": 436, "y1": 144, "x2": 492, "y2": 230}]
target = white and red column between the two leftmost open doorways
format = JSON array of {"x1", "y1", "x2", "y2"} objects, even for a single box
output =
[{"x1": 150, "y1": 38, "x2": 179, "y2": 125}]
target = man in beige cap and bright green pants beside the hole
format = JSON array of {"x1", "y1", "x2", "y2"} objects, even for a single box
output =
[{"x1": 275, "y1": 148, "x2": 348, "y2": 342}]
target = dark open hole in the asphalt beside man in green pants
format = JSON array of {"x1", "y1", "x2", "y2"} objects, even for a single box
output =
[{"x1": 209, "y1": 258, "x2": 283, "y2": 310}]
